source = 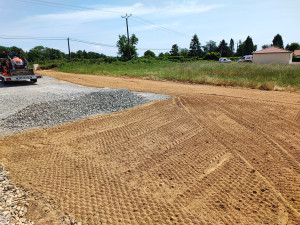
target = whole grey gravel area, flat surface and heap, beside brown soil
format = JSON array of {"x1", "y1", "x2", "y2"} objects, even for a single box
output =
[{"x1": 0, "y1": 77, "x2": 169, "y2": 137}]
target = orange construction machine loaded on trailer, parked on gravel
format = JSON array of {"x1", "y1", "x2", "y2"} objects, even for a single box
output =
[{"x1": 0, "y1": 52, "x2": 43, "y2": 84}]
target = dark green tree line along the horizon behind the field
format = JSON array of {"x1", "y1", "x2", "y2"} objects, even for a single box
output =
[{"x1": 0, "y1": 34, "x2": 300, "y2": 62}]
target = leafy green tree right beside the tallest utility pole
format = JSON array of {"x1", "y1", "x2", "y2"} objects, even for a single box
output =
[{"x1": 117, "y1": 34, "x2": 139, "y2": 60}]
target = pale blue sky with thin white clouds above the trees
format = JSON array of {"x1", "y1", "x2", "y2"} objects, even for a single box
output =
[{"x1": 0, "y1": 0, "x2": 300, "y2": 56}]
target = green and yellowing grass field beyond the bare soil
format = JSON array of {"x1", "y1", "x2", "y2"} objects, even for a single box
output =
[{"x1": 58, "y1": 60, "x2": 300, "y2": 91}]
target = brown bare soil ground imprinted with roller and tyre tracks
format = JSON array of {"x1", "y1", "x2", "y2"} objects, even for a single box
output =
[{"x1": 0, "y1": 71, "x2": 300, "y2": 224}]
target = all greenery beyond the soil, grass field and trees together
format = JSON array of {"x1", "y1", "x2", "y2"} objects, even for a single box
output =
[{"x1": 0, "y1": 34, "x2": 300, "y2": 91}]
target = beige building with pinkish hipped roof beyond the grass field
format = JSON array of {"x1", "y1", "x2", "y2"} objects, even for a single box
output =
[{"x1": 253, "y1": 46, "x2": 293, "y2": 64}]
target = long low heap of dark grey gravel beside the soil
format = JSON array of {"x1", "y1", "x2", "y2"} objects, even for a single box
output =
[{"x1": 2, "y1": 89, "x2": 148, "y2": 130}]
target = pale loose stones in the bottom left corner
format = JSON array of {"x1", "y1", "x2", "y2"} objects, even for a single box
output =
[{"x1": 0, "y1": 165, "x2": 33, "y2": 225}]
